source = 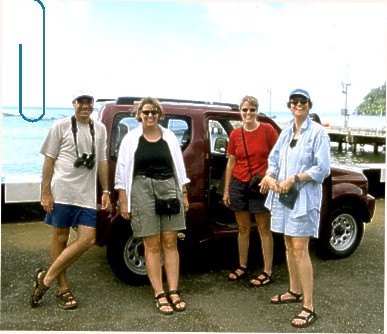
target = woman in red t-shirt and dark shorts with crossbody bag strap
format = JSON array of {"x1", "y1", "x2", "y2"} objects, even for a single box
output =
[{"x1": 223, "y1": 96, "x2": 278, "y2": 287}]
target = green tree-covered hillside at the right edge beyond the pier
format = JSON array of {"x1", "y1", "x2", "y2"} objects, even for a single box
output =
[{"x1": 355, "y1": 83, "x2": 386, "y2": 116}]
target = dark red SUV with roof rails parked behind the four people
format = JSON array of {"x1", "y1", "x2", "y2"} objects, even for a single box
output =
[{"x1": 97, "y1": 97, "x2": 375, "y2": 284}]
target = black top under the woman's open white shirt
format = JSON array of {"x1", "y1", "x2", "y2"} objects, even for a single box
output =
[{"x1": 134, "y1": 136, "x2": 174, "y2": 180}]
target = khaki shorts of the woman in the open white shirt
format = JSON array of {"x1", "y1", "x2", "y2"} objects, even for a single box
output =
[{"x1": 131, "y1": 176, "x2": 185, "y2": 237}]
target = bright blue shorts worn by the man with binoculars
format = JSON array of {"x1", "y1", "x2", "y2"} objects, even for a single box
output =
[{"x1": 44, "y1": 203, "x2": 97, "y2": 228}]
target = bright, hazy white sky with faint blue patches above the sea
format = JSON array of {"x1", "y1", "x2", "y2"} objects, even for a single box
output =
[{"x1": 0, "y1": 0, "x2": 387, "y2": 115}]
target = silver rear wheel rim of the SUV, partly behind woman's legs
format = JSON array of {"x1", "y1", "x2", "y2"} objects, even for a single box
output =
[{"x1": 124, "y1": 237, "x2": 146, "y2": 275}]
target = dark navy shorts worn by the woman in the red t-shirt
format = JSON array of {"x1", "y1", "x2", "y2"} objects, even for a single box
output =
[{"x1": 229, "y1": 177, "x2": 269, "y2": 213}]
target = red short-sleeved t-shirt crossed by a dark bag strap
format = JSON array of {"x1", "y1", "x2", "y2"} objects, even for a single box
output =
[{"x1": 227, "y1": 123, "x2": 278, "y2": 182}]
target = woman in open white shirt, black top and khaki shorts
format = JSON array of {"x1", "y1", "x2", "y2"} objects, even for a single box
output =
[{"x1": 115, "y1": 98, "x2": 189, "y2": 314}]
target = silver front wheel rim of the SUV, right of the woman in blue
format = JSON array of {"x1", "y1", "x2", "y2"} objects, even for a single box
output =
[{"x1": 330, "y1": 214, "x2": 358, "y2": 251}]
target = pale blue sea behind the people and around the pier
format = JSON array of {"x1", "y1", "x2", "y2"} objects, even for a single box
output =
[{"x1": 1, "y1": 107, "x2": 386, "y2": 182}]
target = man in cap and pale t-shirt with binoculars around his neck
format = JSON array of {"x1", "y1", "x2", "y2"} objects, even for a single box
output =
[{"x1": 30, "y1": 95, "x2": 110, "y2": 309}]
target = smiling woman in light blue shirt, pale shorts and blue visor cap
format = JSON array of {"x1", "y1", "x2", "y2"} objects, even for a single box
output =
[{"x1": 261, "y1": 89, "x2": 330, "y2": 327}]
